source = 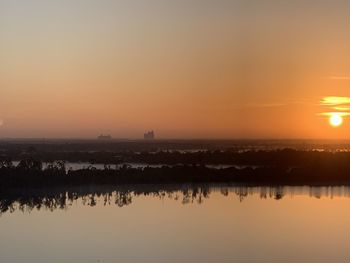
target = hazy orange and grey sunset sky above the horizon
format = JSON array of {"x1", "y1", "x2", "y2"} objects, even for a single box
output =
[{"x1": 0, "y1": 0, "x2": 350, "y2": 139}]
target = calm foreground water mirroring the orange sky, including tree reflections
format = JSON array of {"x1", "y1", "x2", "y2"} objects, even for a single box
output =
[{"x1": 0, "y1": 186, "x2": 350, "y2": 263}]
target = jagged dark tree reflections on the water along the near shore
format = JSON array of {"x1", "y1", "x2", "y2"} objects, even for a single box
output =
[{"x1": 0, "y1": 185, "x2": 350, "y2": 217}]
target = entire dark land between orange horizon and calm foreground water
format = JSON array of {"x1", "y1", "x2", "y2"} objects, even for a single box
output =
[{"x1": 0, "y1": 140, "x2": 350, "y2": 191}]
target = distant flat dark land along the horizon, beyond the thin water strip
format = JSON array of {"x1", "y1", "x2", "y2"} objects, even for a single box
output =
[{"x1": 0, "y1": 140, "x2": 350, "y2": 166}]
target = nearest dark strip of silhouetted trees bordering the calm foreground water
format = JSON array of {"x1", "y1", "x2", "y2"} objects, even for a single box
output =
[{"x1": 0, "y1": 153, "x2": 350, "y2": 191}]
